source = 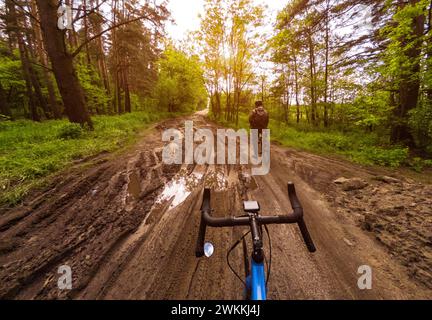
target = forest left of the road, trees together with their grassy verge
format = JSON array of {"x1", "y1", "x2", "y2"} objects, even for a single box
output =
[{"x1": 0, "y1": 0, "x2": 208, "y2": 203}]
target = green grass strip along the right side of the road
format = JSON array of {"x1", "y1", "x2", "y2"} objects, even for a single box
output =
[{"x1": 212, "y1": 114, "x2": 412, "y2": 168}]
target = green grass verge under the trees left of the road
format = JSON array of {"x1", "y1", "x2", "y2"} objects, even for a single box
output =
[{"x1": 0, "y1": 112, "x2": 167, "y2": 205}]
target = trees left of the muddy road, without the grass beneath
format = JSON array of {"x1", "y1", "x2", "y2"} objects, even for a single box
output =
[{"x1": 0, "y1": 0, "x2": 205, "y2": 122}]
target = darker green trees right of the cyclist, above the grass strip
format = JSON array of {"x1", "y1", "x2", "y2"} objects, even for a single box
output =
[{"x1": 268, "y1": 0, "x2": 432, "y2": 159}]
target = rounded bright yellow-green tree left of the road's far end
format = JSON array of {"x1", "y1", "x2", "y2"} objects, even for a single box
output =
[{"x1": 155, "y1": 48, "x2": 207, "y2": 112}]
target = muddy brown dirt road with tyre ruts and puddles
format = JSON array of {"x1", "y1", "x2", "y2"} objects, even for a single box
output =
[{"x1": 0, "y1": 114, "x2": 432, "y2": 299}]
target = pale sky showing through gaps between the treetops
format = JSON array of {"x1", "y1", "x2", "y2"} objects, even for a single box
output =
[{"x1": 167, "y1": 0, "x2": 288, "y2": 41}]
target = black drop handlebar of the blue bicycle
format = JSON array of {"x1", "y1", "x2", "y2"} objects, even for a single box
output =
[{"x1": 195, "y1": 182, "x2": 316, "y2": 258}]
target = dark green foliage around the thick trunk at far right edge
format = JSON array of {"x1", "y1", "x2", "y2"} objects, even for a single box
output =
[{"x1": 375, "y1": 0, "x2": 432, "y2": 154}]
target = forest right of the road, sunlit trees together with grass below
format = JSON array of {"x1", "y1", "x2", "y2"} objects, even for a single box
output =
[{"x1": 198, "y1": 0, "x2": 432, "y2": 170}]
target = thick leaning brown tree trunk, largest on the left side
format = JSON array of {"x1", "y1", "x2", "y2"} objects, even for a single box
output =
[{"x1": 36, "y1": 0, "x2": 93, "y2": 128}]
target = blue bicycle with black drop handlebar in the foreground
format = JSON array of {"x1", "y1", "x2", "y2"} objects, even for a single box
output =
[{"x1": 195, "y1": 182, "x2": 316, "y2": 300}]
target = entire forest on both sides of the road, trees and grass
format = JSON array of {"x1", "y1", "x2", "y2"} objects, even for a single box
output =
[{"x1": 0, "y1": 0, "x2": 432, "y2": 201}]
